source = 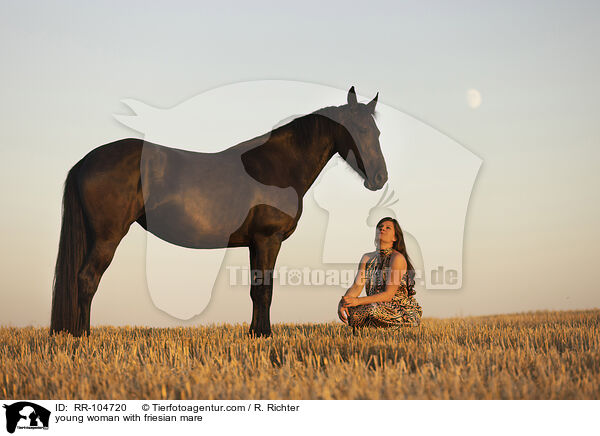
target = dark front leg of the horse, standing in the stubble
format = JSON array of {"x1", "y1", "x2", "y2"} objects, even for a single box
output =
[{"x1": 250, "y1": 234, "x2": 282, "y2": 336}]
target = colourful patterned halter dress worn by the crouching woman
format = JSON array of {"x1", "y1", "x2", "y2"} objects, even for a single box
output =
[{"x1": 348, "y1": 248, "x2": 423, "y2": 328}]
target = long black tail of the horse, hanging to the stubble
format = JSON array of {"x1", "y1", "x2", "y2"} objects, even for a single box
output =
[{"x1": 50, "y1": 161, "x2": 88, "y2": 336}]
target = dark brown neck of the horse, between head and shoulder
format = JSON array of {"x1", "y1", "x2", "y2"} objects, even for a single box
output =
[{"x1": 242, "y1": 113, "x2": 337, "y2": 197}]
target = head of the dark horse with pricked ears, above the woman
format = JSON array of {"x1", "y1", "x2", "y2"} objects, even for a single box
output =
[{"x1": 336, "y1": 86, "x2": 388, "y2": 191}]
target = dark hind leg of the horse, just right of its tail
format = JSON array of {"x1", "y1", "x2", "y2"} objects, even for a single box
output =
[{"x1": 78, "y1": 234, "x2": 125, "y2": 334}]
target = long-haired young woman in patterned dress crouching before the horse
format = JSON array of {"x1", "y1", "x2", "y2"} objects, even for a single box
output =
[{"x1": 338, "y1": 217, "x2": 423, "y2": 328}]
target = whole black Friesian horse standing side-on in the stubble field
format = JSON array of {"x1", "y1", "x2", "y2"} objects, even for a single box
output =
[{"x1": 50, "y1": 87, "x2": 387, "y2": 336}]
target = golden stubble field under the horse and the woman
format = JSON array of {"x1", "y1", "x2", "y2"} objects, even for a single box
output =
[{"x1": 0, "y1": 309, "x2": 600, "y2": 400}]
